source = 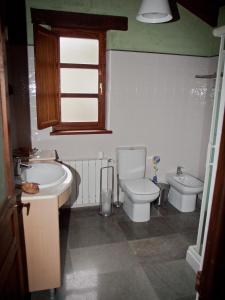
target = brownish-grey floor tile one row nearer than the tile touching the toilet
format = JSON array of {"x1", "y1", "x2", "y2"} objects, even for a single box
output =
[{"x1": 129, "y1": 234, "x2": 189, "y2": 264}]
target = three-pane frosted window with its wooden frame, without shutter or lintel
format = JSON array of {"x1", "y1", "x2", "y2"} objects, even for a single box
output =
[{"x1": 55, "y1": 30, "x2": 106, "y2": 130}]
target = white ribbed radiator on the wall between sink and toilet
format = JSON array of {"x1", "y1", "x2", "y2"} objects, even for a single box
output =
[{"x1": 63, "y1": 159, "x2": 112, "y2": 207}]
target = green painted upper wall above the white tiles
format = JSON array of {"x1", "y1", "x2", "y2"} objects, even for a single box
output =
[{"x1": 26, "y1": 0, "x2": 225, "y2": 56}]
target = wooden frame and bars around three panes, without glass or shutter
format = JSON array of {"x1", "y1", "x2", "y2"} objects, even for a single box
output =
[{"x1": 53, "y1": 28, "x2": 106, "y2": 132}]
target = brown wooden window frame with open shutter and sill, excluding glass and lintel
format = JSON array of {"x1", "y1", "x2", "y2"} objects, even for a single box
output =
[{"x1": 34, "y1": 25, "x2": 111, "y2": 135}]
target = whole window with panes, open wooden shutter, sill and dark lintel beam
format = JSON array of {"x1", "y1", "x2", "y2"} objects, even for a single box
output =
[{"x1": 31, "y1": 8, "x2": 128, "y2": 134}]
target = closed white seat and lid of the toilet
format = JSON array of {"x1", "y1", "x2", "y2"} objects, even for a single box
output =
[{"x1": 120, "y1": 177, "x2": 160, "y2": 203}]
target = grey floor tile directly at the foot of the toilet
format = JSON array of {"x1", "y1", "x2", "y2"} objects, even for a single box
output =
[{"x1": 118, "y1": 217, "x2": 174, "y2": 240}]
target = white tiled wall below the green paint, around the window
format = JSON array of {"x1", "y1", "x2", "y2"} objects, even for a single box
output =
[{"x1": 29, "y1": 46, "x2": 216, "y2": 180}]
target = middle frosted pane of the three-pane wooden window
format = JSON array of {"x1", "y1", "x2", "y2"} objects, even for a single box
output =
[{"x1": 60, "y1": 68, "x2": 98, "y2": 94}]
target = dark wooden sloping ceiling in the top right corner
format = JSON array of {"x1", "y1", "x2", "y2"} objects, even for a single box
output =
[{"x1": 177, "y1": 0, "x2": 225, "y2": 27}]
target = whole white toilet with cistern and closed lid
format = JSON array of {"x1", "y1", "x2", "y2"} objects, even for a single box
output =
[{"x1": 117, "y1": 147, "x2": 160, "y2": 222}]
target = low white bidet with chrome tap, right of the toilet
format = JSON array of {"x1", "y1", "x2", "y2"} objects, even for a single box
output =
[{"x1": 166, "y1": 173, "x2": 203, "y2": 212}]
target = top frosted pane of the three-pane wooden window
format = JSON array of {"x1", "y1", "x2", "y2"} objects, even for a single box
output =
[{"x1": 60, "y1": 37, "x2": 99, "y2": 65}]
